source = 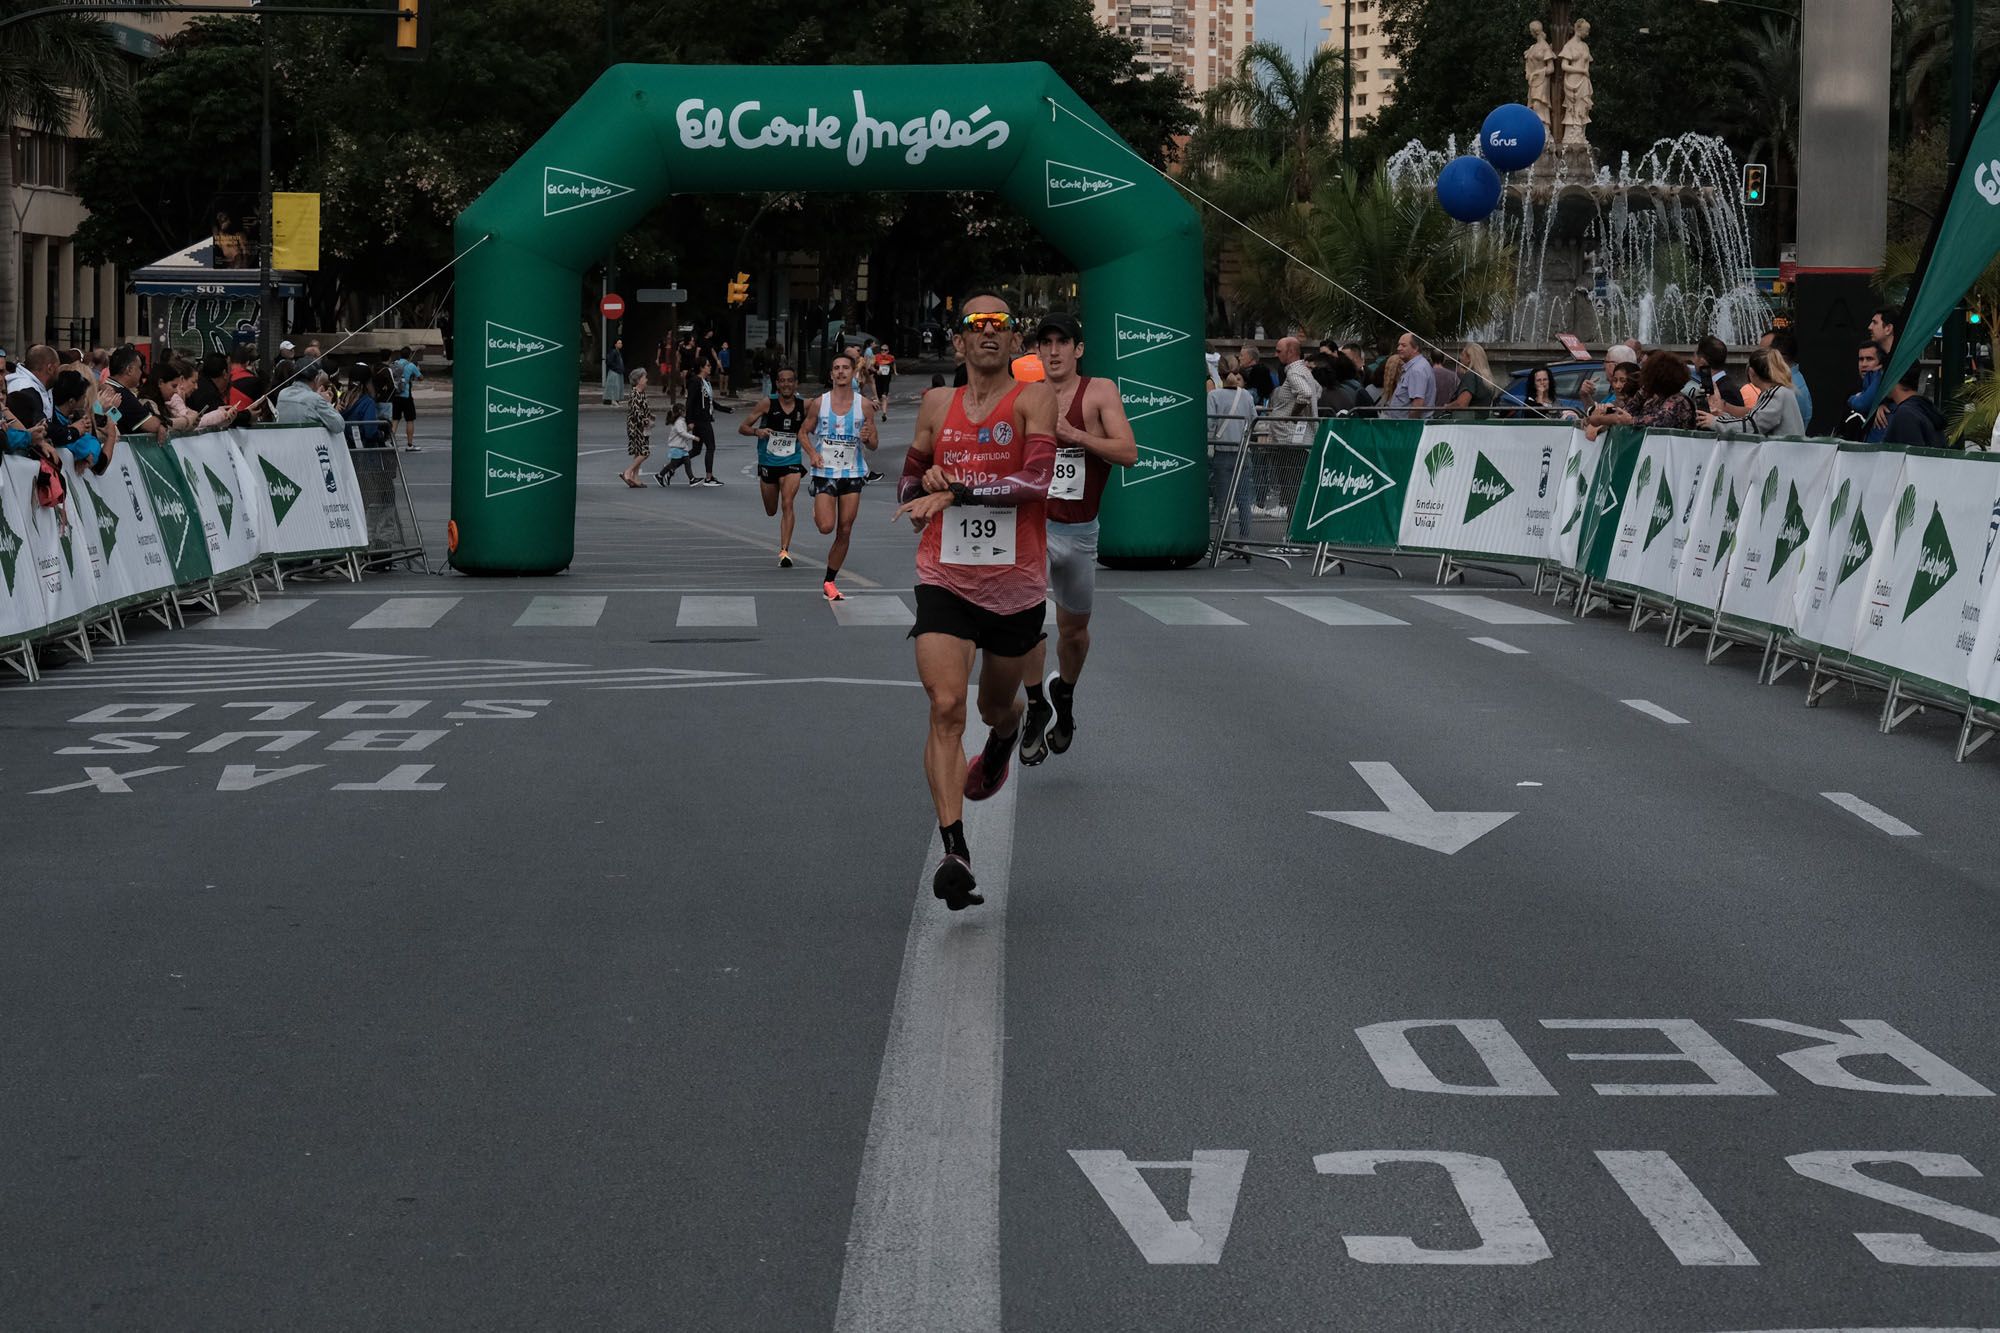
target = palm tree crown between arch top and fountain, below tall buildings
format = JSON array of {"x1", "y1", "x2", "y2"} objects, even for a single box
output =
[{"x1": 1186, "y1": 42, "x2": 1348, "y2": 215}]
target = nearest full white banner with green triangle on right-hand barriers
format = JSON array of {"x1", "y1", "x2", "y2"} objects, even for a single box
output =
[{"x1": 1854, "y1": 448, "x2": 2000, "y2": 693}]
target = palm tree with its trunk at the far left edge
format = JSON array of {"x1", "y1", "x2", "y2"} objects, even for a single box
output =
[{"x1": 0, "y1": 0, "x2": 130, "y2": 344}]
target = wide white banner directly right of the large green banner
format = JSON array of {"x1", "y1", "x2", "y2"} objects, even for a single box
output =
[{"x1": 1398, "y1": 424, "x2": 1572, "y2": 560}]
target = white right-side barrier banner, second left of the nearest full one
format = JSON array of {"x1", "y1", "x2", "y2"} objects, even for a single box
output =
[{"x1": 1722, "y1": 440, "x2": 1840, "y2": 628}]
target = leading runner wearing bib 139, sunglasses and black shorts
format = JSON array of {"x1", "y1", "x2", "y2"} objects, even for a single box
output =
[{"x1": 896, "y1": 292, "x2": 1056, "y2": 913}]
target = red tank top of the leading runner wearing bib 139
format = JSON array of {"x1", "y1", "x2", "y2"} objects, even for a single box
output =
[{"x1": 916, "y1": 384, "x2": 1048, "y2": 616}]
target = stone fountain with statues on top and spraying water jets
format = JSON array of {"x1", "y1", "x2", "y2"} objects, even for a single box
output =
[{"x1": 1388, "y1": 4, "x2": 1770, "y2": 346}]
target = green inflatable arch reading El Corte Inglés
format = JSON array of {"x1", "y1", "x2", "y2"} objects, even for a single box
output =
[{"x1": 452, "y1": 64, "x2": 1208, "y2": 574}]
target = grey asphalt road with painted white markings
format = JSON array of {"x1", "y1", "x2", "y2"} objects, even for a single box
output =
[{"x1": 0, "y1": 390, "x2": 2000, "y2": 1331}]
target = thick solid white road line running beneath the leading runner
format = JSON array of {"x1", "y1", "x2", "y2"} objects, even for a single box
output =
[{"x1": 834, "y1": 736, "x2": 1020, "y2": 1333}]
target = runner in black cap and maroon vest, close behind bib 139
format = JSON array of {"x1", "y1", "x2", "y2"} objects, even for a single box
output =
[{"x1": 1020, "y1": 310, "x2": 1138, "y2": 765}]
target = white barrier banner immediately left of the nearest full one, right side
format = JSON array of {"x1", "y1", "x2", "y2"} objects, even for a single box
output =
[{"x1": 1792, "y1": 444, "x2": 1902, "y2": 654}]
